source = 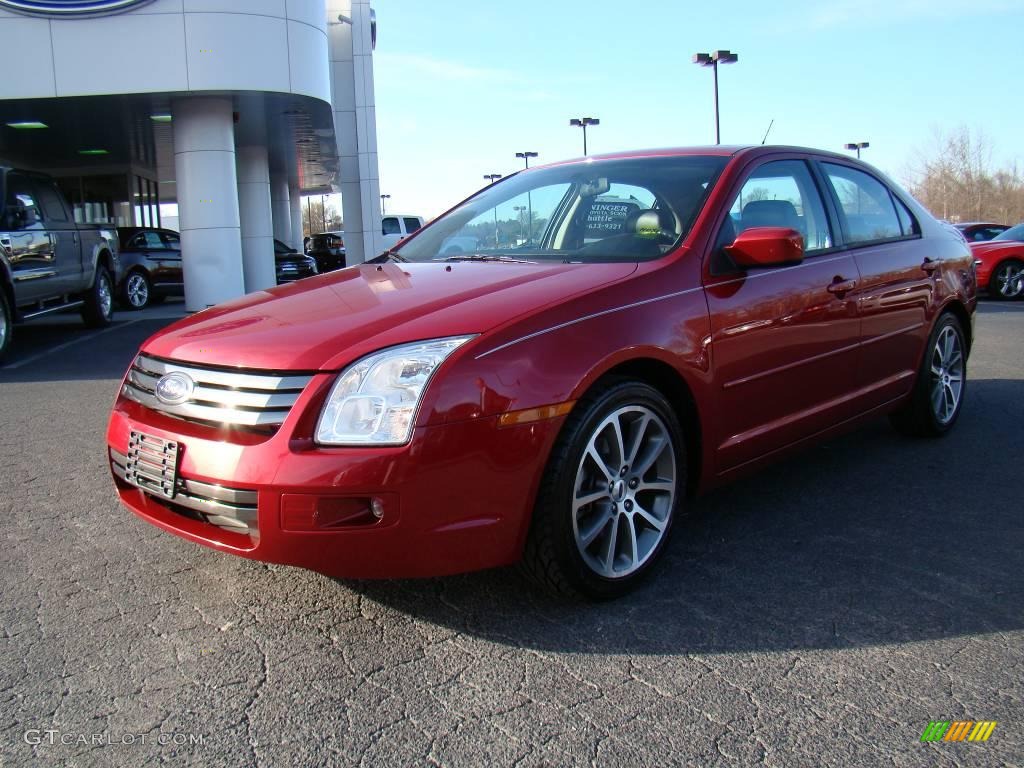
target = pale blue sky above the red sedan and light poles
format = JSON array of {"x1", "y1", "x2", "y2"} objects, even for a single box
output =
[{"x1": 364, "y1": 0, "x2": 1024, "y2": 218}]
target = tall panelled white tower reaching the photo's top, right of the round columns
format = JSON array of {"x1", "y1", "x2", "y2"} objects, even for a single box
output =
[{"x1": 327, "y1": 0, "x2": 383, "y2": 264}]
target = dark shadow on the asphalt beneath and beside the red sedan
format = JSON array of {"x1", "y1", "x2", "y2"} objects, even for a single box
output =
[{"x1": 339, "y1": 379, "x2": 1024, "y2": 653}]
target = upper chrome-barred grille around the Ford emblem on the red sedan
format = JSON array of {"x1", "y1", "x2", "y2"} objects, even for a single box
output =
[{"x1": 122, "y1": 354, "x2": 312, "y2": 427}]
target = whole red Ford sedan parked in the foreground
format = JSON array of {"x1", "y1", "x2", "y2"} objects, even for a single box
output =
[{"x1": 108, "y1": 146, "x2": 976, "y2": 597}]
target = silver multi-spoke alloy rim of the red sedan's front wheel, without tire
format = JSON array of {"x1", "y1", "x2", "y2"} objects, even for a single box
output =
[{"x1": 572, "y1": 406, "x2": 676, "y2": 579}]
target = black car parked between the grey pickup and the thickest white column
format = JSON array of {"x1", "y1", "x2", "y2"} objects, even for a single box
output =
[{"x1": 118, "y1": 226, "x2": 184, "y2": 309}]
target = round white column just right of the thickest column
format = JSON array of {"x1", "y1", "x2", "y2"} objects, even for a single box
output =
[{"x1": 238, "y1": 146, "x2": 278, "y2": 293}]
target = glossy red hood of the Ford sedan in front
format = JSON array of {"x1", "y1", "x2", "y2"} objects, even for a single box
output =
[{"x1": 142, "y1": 262, "x2": 637, "y2": 371}]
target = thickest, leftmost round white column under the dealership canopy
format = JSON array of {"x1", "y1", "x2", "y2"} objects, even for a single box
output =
[{"x1": 171, "y1": 96, "x2": 245, "y2": 312}]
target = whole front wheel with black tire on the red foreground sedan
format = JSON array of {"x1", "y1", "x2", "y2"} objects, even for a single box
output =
[{"x1": 522, "y1": 380, "x2": 686, "y2": 600}]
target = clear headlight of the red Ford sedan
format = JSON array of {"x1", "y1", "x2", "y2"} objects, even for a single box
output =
[{"x1": 316, "y1": 336, "x2": 473, "y2": 445}]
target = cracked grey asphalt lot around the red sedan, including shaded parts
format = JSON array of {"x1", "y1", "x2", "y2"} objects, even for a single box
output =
[{"x1": 0, "y1": 302, "x2": 1024, "y2": 767}]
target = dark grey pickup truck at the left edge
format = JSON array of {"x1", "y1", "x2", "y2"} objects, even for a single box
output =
[{"x1": 0, "y1": 167, "x2": 118, "y2": 361}]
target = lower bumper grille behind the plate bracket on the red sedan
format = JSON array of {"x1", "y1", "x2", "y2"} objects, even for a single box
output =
[{"x1": 110, "y1": 449, "x2": 259, "y2": 535}]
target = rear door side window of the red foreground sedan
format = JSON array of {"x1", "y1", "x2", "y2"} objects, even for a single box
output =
[{"x1": 821, "y1": 163, "x2": 914, "y2": 243}]
